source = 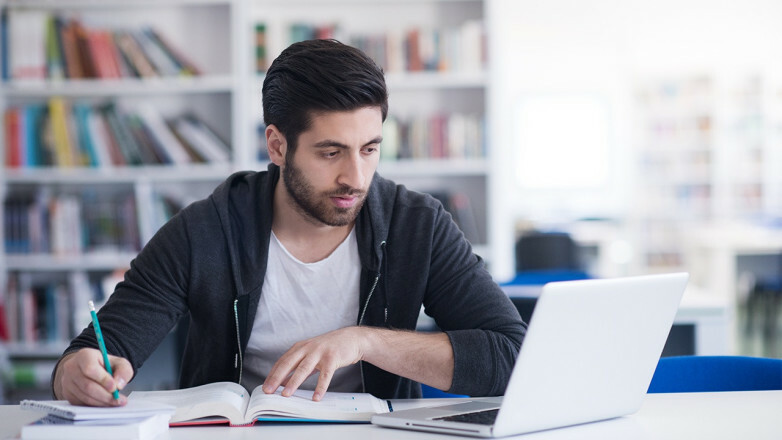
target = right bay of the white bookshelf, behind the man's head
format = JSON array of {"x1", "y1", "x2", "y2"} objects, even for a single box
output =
[{"x1": 248, "y1": 0, "x2": 491, "y2": 254}]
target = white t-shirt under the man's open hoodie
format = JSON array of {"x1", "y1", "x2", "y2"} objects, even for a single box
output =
[{"x1": 242, "y1": 229, "x2": 362, "y2": 392}]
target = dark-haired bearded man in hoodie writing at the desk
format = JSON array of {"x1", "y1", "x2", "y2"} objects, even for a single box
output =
[{"x1": 53, "y1": 40, "x2": 526, "y2": 405}]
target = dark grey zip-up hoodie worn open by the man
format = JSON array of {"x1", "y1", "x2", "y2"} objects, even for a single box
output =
[{"x1": 61, "y1": 164, "x2": 526, "y2": 398}]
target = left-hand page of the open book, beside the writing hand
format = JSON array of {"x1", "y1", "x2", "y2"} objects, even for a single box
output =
[{"x1": 128, "y1": 382, "x2": 250, "y2": 425}]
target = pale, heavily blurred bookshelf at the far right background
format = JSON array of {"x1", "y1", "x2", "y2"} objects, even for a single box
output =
[{"x1": 634, "y1": 70, "x2": 782, "y2": 271}]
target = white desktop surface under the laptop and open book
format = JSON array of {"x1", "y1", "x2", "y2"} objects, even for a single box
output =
[{"x1": 0, "y1": 391, "x2": 782, "y2": 440}]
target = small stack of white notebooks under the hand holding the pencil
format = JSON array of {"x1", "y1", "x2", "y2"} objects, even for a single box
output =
[{"x1": 20, "y1": 400, "x2": 174, "y2": 440}]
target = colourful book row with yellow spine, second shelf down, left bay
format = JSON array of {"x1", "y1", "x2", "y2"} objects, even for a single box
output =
[{"x1": 4, "y1": 97, "x2": 231, "y2": 168}]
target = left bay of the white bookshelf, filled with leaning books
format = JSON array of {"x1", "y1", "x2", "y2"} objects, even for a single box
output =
[{"x1": 0, "y1": 0, "x2": 251, "y2": 400}]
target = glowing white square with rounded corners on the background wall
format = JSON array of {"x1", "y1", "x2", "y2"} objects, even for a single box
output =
[{"x1": 514, "y1": 95, "x2": 610, "y2": 190}]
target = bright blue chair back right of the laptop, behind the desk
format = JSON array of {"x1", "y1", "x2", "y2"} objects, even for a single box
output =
[{"x1": 648, "y1": 356, "x2": 782, "y2": 393}]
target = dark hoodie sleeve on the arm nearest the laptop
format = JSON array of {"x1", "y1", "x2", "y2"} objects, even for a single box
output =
[{"x1": 424, "y1": 206, "x2": 527, "y2": 396}]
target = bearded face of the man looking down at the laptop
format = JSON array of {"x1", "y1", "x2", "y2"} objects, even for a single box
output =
[{"x1": 282, "y1": 107, "x2": 383, "y2": 226}]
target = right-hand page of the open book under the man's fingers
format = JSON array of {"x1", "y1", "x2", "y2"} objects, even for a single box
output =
[{"x1": 247, "y1": 386, "x2": 388, "y2": 422}]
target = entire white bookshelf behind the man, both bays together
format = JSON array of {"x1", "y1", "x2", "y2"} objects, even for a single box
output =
[{"x1": 0, "y1": 0, "x2": 493, "y2": 400}]
